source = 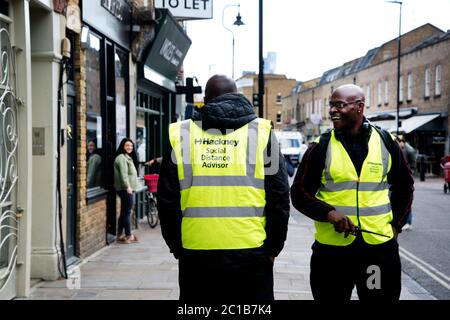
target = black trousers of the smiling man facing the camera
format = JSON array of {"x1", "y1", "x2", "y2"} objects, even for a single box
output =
[{"x1": 310, "y1": 236, "x2": 401, "y2": 301}]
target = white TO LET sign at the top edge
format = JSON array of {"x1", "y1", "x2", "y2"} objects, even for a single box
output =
[{"x1": 155, "y1": 0, "x2": 212, "y2": 20}]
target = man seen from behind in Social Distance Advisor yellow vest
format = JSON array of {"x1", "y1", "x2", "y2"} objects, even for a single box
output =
[{"x1": 157, "y1": 75, "x2": 290, "y2": 301}]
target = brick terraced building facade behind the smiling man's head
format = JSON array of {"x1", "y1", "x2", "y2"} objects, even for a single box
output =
[{"x1": 285, "y1": 24, "x2": 450, "y2": 166}]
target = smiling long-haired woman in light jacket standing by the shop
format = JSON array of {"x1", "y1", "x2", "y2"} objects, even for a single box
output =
[{"x1": 114, "y1": 138, "x2": 139, "y2": 243}]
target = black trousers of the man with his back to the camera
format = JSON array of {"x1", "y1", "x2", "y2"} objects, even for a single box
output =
[{"x1": 179, "y1": 250, "x2": 274, "y2": 302}]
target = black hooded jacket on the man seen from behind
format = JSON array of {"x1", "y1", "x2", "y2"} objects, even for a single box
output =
[{"x1": 157, "y1": 93, "x2": 290, "y2": 263}]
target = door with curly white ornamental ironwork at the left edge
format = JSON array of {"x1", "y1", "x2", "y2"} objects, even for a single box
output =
[{"x1": 0, "y1": 15, "x2": 20, "y2": 300}]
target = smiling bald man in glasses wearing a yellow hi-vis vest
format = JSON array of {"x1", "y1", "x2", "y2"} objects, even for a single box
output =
[{"x1": 291, "y1": 84, "x2": 414, "y2": 301}]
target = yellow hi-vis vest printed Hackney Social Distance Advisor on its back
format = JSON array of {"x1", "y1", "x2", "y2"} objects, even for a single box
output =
[{"x1": 169, "y1": 118, "x2": 271, "y2": 250}]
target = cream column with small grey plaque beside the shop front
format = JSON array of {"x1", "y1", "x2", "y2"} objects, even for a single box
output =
[{"x1": 30, "y1": 8, "x2": 67, "y2": 280}]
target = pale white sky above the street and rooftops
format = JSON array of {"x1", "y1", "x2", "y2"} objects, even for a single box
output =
[{"x1": 184, "y1": 0, "x2": 450, "y2": 86}]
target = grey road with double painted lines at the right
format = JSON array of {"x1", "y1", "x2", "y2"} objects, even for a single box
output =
[{"x1": 399, "y1": 178, "x2": 450, "y2": 300}]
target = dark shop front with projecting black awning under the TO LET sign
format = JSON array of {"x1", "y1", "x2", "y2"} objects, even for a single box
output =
[{"x1": 136, "y1": 9, "x2": 191, "y2": 175}]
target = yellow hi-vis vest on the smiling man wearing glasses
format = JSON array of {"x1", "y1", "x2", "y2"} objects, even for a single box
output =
[{"x1": 315, "y1": 130, "x2": 393, "y2": 246}]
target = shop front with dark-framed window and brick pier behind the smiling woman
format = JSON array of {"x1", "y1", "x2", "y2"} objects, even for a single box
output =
[{"x1": 74, "y1": 0, "x2": 133, "y2": 257}]
